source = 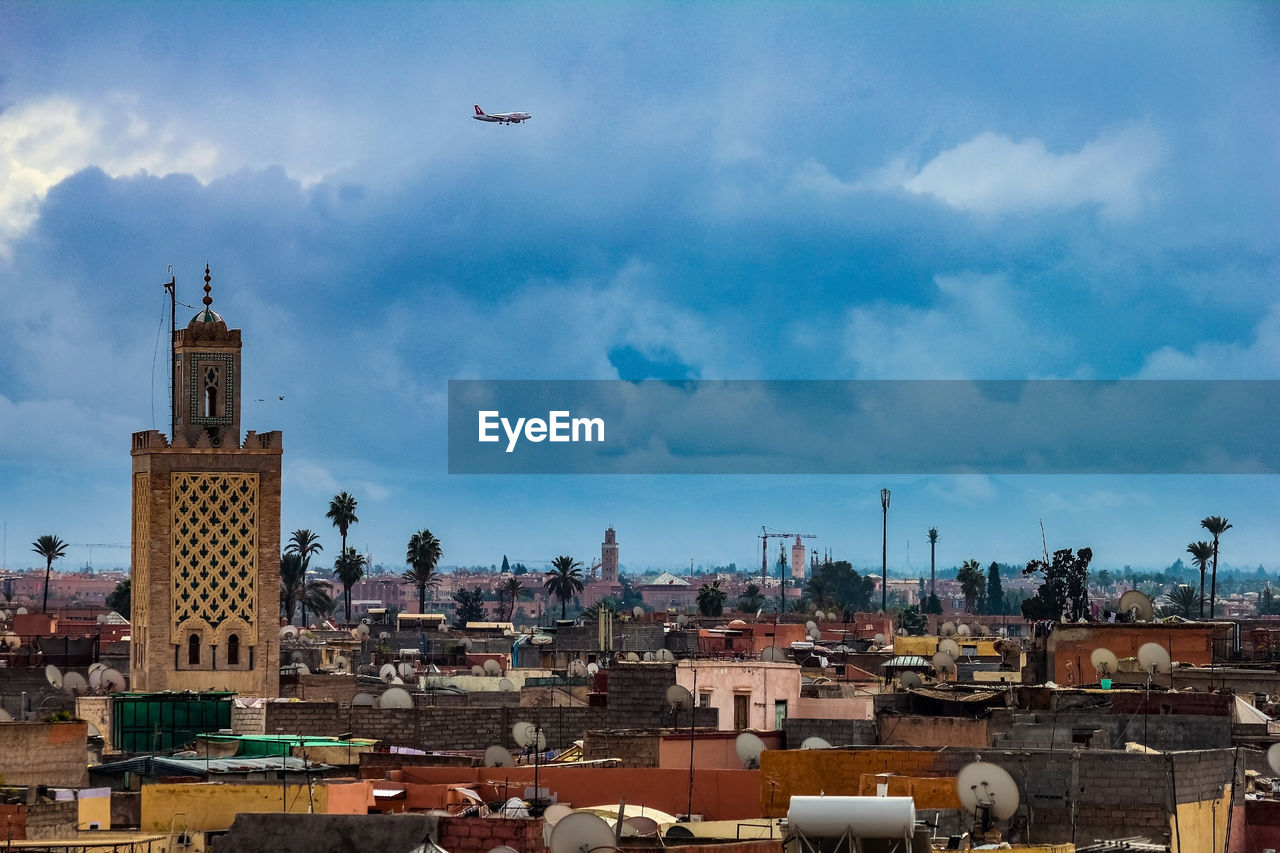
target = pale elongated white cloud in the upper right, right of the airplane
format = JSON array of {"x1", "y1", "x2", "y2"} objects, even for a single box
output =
[{"x1": 901, "y1": 126, "x2": 1162, "y2": 218}]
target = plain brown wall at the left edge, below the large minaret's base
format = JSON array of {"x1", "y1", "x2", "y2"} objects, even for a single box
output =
[{"x1": 0, "y1": 722, "x2": 88, "y2": 788}]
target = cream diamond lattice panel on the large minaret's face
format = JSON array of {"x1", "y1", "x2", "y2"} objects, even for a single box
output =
[{"x1": 173, "y1": 473, "x2": 259, "y2": 637}]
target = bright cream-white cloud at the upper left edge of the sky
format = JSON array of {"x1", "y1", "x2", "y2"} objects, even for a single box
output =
[{"x1": 0, "y1": 96, "x2": 218, "y2": 254}]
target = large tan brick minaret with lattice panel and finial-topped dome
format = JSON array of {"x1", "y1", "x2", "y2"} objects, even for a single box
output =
[{"x1": 131, "y1": 265, "x2": 283, "y2": 697}]
